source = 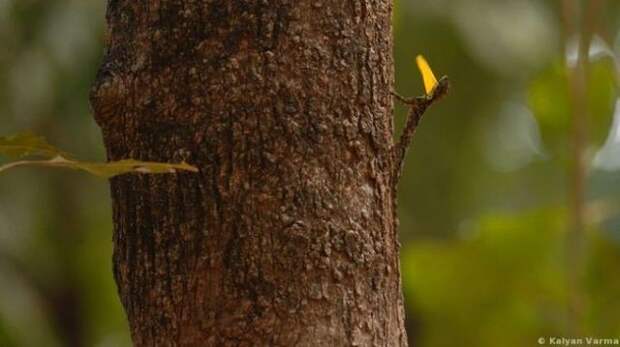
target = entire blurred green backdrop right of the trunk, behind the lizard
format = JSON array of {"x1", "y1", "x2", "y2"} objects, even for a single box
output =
[{"x1": 395, "y1": 0, "x2": 620, "y2": 346}]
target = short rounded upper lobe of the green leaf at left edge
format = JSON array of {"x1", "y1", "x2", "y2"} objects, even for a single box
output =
[{"x1": 0, "y1": 132, "x2": 69, "y2": 159}]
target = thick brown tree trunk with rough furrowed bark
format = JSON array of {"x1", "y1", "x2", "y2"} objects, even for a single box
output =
[{"x1": 91, "y1": 0, "x2": 406, "y2": 346}]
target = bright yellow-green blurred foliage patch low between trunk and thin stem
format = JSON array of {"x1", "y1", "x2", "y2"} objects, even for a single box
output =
[{"x1": 402, "y1": 210, "x2": 565, "y2": 346}]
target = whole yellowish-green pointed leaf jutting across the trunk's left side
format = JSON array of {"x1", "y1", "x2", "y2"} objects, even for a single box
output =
[{"x1": 0, "y1": 133, "x2": 198, "y2": 178}]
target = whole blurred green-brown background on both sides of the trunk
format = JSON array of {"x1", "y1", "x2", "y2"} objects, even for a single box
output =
[{"x1": 0, "y1": 0, "x2": 620, "y2": 347}]
